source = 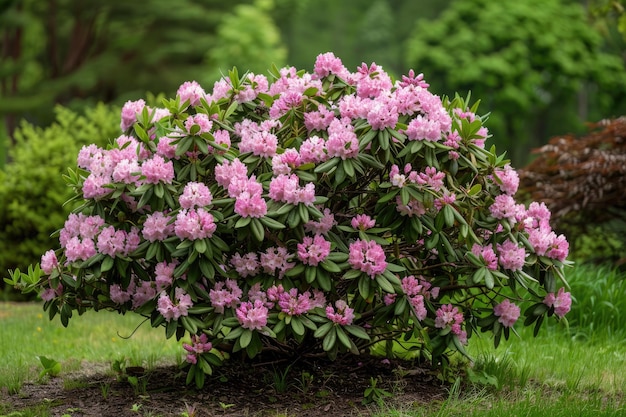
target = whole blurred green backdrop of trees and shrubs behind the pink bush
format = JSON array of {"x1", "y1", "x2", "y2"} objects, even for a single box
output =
[{"x1": 0, "y1": 0, "x2": 626, "y2": 292}]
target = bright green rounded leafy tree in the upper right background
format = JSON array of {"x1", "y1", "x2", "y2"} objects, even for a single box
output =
[{"x1": 407, "y1": 0, "x2": 626, "y2": 164}]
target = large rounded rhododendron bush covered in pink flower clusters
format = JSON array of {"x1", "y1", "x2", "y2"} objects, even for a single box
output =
[{"x1": 8, "y1": 53, "x2": 571, "y2": 385}]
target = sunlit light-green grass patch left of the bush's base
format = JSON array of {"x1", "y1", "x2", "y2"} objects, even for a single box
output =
[{"x1": 0, "y1": 303, "x2": 181, "y2": 391}]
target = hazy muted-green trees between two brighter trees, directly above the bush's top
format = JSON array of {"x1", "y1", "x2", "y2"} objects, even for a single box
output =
[{"x1": 272, "y1": 0, "x2": 451, "y2": 74}]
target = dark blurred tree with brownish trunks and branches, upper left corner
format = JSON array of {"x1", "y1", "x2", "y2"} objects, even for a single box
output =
[{"x1": 0, "y1": 0, "x2": 243, "y2": 145}]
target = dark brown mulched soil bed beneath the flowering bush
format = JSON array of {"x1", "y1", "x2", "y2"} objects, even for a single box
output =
[{"x1": 0, "y1": 357, "x2": 448, "y2": 417}]
